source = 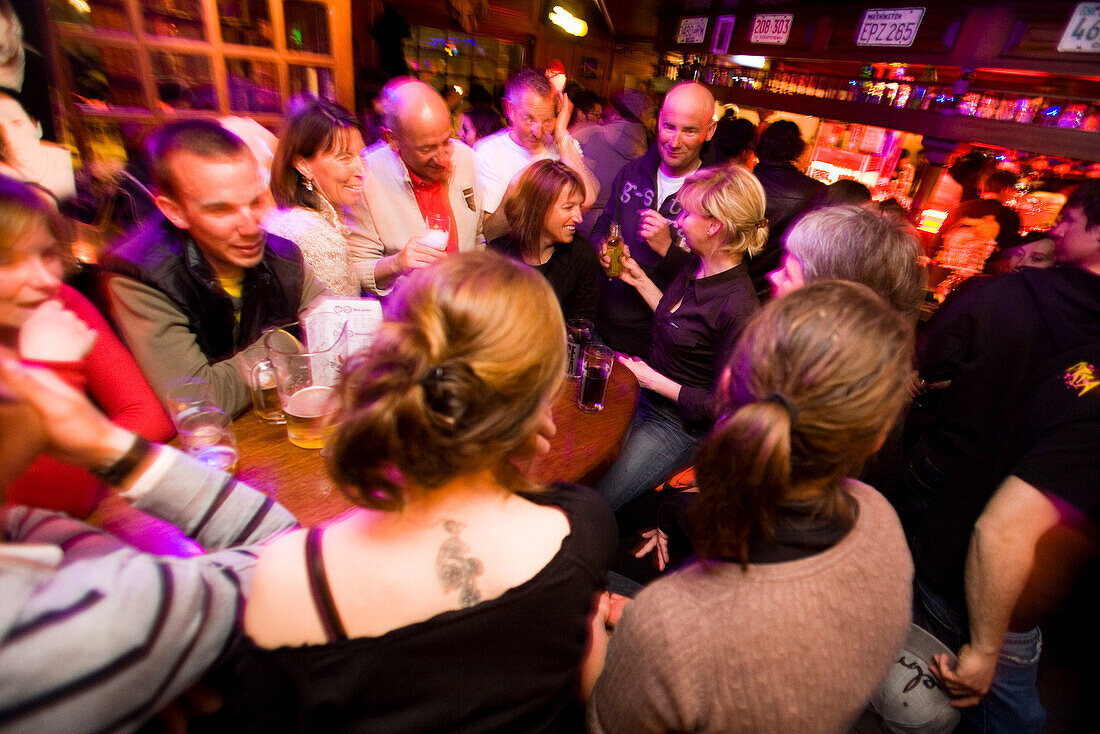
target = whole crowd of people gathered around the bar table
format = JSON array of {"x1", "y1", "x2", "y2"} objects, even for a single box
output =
[{"x1": 0, "y1": 69, "x2": 1100, "y2": 733}]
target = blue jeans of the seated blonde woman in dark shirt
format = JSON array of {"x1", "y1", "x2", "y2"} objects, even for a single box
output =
[{"x1": 595, "y1": 394, "x2": 704, "y2": 511}]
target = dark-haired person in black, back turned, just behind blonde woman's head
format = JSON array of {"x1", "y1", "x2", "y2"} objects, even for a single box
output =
[{"x1": 749, "y1": 120, "x2": 825, "y2": 300}]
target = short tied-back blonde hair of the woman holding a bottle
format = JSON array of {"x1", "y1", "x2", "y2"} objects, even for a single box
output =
[{"x1": 677, "y1": 165, "x2": 768, "y2": 258}]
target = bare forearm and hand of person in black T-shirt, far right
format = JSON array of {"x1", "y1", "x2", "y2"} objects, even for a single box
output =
[{"x1": 932, "y1": 476, "x2": 1063, "y2": 706}]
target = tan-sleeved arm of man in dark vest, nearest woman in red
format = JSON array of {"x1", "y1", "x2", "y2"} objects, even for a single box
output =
[{"x1": 107, "y1": 274, "x2": 252, "y2": 413}]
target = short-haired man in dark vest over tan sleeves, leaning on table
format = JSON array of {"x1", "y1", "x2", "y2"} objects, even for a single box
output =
[{"x1": 103, "y1": 120, "x2": 326, "y2": 413}]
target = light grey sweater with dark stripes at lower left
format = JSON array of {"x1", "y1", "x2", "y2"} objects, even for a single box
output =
[{"x1": 0, "y1": 449, "x2": 295, "y2": 734}]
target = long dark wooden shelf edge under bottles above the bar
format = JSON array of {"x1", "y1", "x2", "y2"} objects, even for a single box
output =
[{"x1": 711, "y1": 86, "x2": 1100, "y2": 161}]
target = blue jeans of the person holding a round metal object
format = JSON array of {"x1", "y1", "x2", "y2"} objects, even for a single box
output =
[{"x1": 913, "y1": 579, "x2": 1046, "y2": 734}]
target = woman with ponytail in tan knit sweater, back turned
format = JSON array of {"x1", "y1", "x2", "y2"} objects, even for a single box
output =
[{"x1": 587, "y1": 282, "x2": 913, "y2": 734}]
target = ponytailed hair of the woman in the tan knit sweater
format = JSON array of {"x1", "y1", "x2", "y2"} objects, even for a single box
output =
[{"x1": 692, "y1": 281, "x2": 913, "y2": 565}]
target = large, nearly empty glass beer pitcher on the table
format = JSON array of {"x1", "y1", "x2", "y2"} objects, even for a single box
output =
[{"x1": 264, "y1": 321, "x2": 348, "y2": 449}]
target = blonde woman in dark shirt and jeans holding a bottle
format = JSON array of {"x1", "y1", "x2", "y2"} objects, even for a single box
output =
[{"x1": 596, "y1": 165, "x2": 768, "y2": 510}]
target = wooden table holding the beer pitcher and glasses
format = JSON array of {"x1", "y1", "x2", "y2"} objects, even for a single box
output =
[{"x1": 233, "y1": 363, "x2": 638, "y2": 526}]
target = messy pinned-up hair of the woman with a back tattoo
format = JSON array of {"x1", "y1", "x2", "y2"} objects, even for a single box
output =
[{"x1": 327, "y1": 252, "x2": 565, "y2": 510}]
